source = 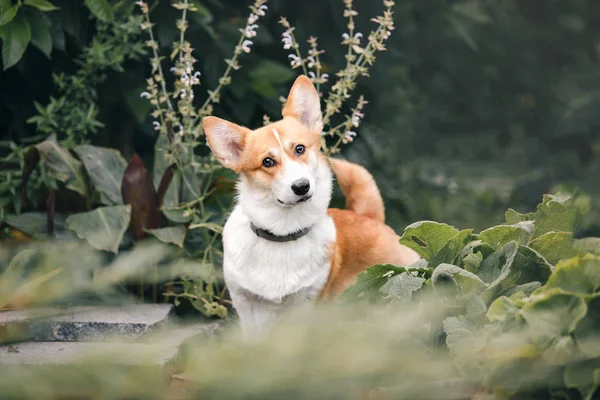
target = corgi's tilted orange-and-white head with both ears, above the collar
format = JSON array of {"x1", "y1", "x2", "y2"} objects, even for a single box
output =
[{"x1": 203, "y1": 76, "x2": 331, "y2": 231}]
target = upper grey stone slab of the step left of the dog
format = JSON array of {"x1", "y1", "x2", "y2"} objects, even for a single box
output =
[{"x1": 0, "y1": 304, "x2": 173, "y2": 342}]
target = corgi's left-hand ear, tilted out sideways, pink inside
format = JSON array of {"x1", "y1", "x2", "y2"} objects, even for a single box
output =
[{"x1": 202, "y1": 117, "x2": 249, "y2": 172}]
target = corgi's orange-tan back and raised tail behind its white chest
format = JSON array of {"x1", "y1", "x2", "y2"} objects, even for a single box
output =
[{"x1": 321, "y1": 158, "x2": 419, "y2": 298}]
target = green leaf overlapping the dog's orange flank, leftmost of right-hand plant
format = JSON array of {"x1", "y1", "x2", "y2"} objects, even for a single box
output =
[{"x1": 338, "y1": 264, "x2": 406, "y2": 303}]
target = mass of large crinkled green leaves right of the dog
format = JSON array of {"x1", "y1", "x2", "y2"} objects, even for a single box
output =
[{"x1": 340, "y1": 194, "x2": 600, "y2": 399}]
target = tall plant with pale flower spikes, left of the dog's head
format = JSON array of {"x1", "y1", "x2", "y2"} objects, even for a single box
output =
[{"x1": 136, "y1": 0, "x2": 268, "y2": 317}]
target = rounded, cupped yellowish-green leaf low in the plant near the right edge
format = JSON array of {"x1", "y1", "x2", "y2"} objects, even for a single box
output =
[{"x1": 520, "y1": 290, "x2": 587, "y2": 344}]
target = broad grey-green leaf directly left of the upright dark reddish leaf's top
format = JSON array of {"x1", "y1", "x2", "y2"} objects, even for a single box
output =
[{"x1": 73, "y1": 144, "x2": 127, "y2": 205}]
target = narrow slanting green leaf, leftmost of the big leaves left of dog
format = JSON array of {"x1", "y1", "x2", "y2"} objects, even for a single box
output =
[{"x1": 35, "y1": 135, "x2": 88, "y2": 198}]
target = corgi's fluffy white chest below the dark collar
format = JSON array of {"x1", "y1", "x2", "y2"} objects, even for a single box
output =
[{"x1": 223, "y1": 207, "x2": 335, "y2": 305}]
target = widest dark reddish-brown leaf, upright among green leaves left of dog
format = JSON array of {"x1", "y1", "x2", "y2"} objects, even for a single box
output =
[{"x1": 121, "y1": 154, "x2": 160, "y2": 240}]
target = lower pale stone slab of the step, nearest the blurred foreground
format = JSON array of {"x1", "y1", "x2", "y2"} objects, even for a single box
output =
[{"x1": 0, "y1": 322, "x2": 220, "y2": 368}]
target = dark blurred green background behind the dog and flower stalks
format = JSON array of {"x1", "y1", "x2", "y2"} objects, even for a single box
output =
[{"x1": 0, "y1": 0, "x2": 600, "y2": 235}]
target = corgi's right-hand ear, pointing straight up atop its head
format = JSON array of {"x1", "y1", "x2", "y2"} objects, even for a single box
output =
[{"x1": 282, "y1": 75, "x2": 323, "y2": 134}]
